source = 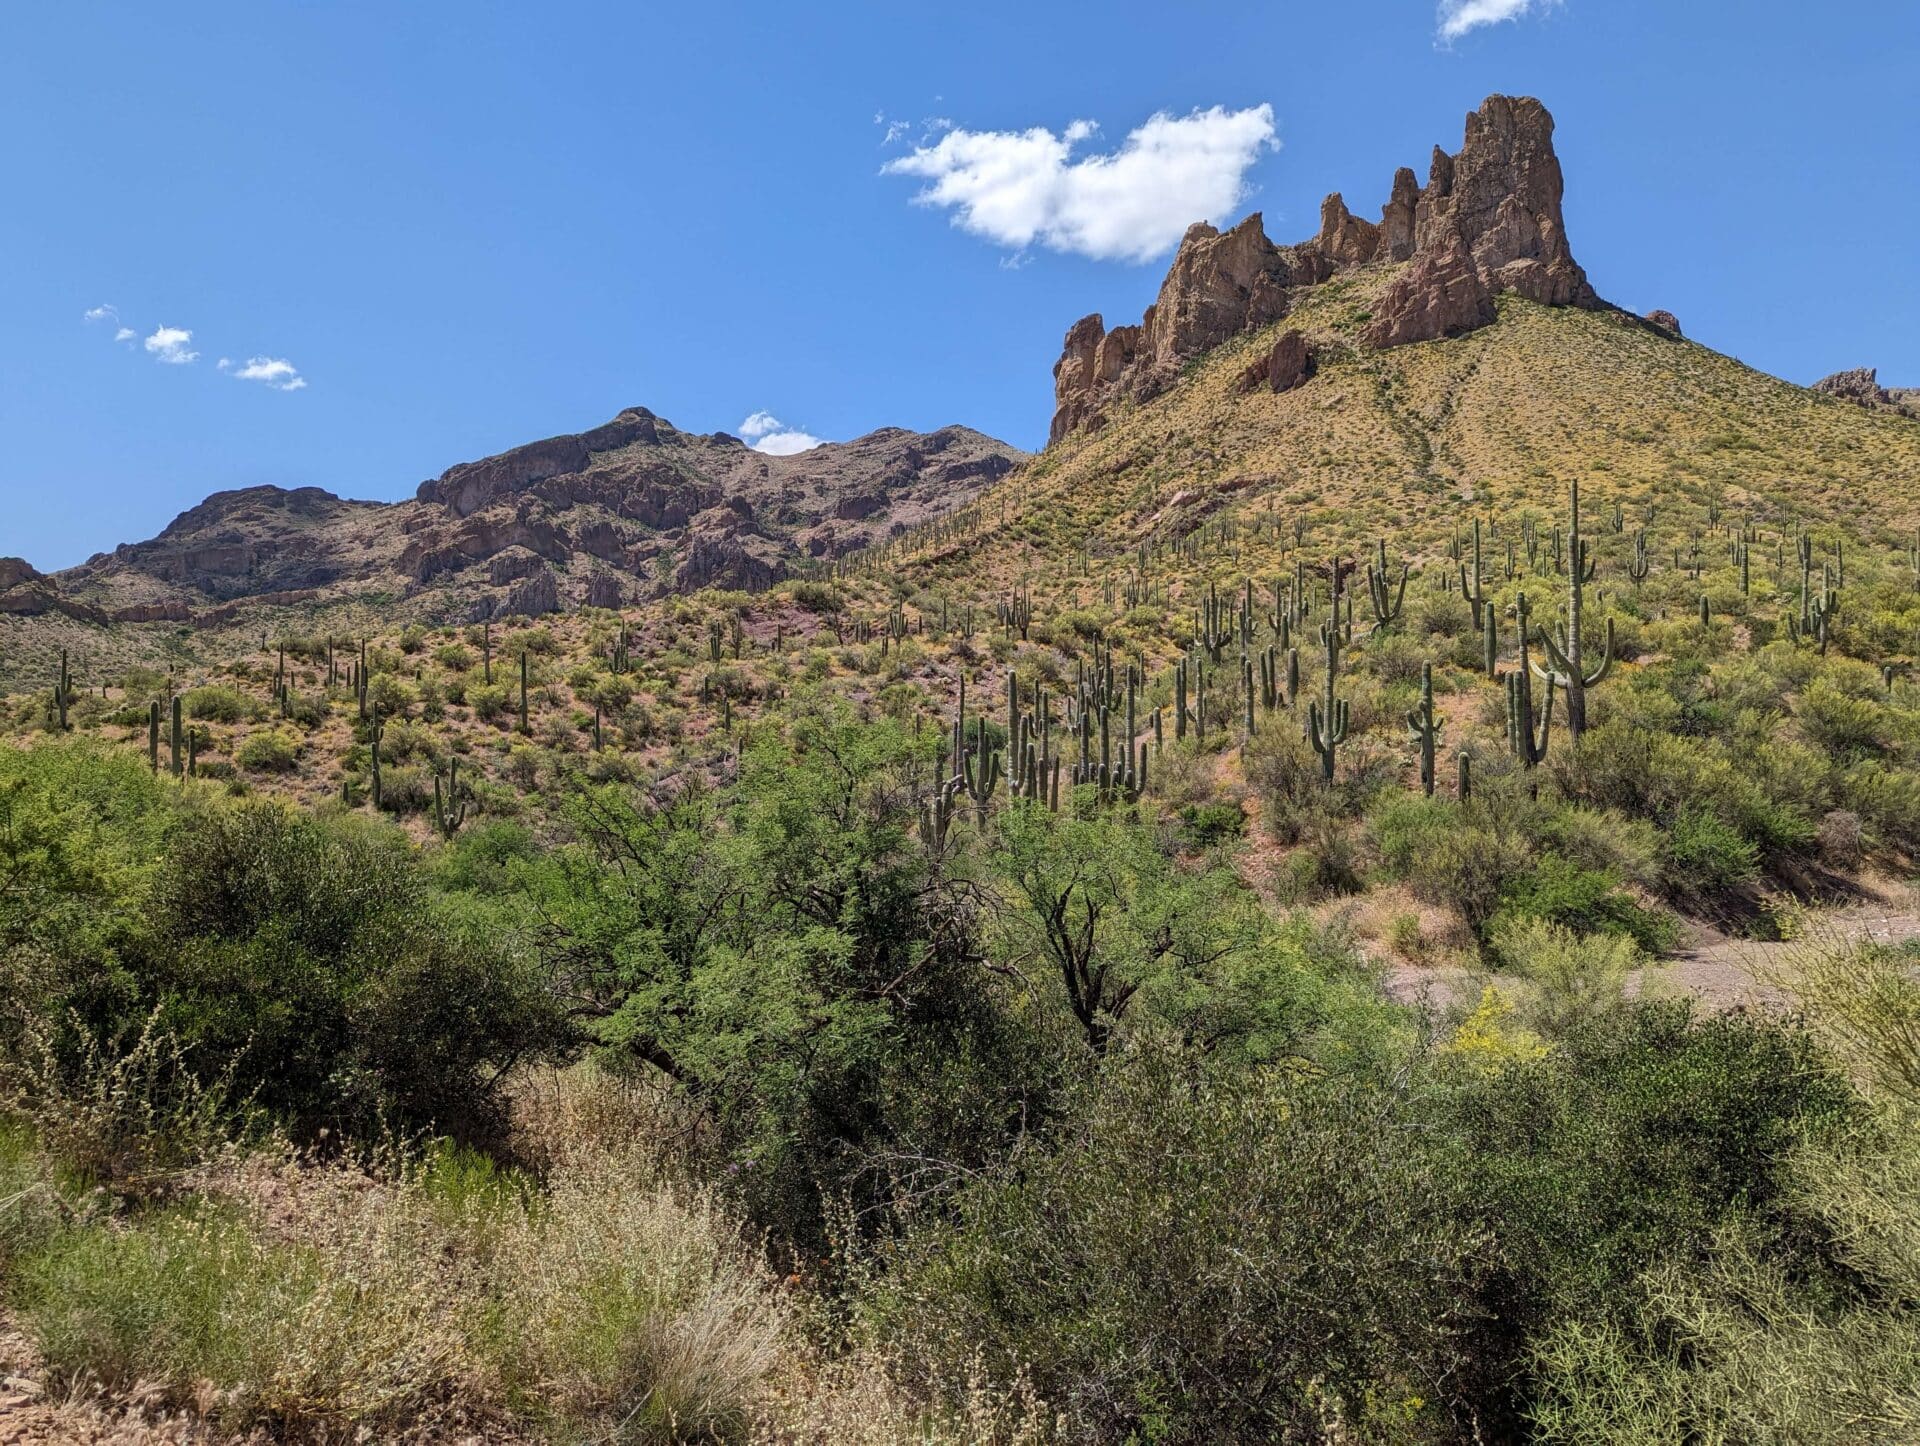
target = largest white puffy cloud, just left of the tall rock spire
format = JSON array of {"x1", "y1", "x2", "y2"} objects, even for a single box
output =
[{"x1": 881, "y1": 106, "x2": 1279, "y2": 261}]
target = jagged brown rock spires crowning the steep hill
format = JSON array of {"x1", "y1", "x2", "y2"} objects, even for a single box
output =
[{"x1": 1050, "y1": 96, "x2": 1601, "y2": 442}]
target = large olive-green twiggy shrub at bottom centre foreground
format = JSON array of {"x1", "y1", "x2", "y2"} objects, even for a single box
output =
[{"x1": 872, "y1": 1050, "x2": 1478, "y2": 1440}]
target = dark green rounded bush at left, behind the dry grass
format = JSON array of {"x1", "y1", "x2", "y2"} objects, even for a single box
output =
[{"x1": 123, "y1": 803, "x2": 561, "y2": 1137}]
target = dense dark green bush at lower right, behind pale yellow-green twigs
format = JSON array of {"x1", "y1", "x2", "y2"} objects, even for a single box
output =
[{"x1": 1444, "y1": 1002, "x2": 1857, "y2": 1438}]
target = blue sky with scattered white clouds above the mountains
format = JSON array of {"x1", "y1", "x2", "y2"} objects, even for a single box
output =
[{"x1": 0, "y1": 0, "x2": 1920, "y2": 568}]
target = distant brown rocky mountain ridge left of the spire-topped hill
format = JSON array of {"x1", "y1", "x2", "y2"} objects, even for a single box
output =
[{"x1": 26, "y1": 407, "x2": 1023, "y2": 622}]
